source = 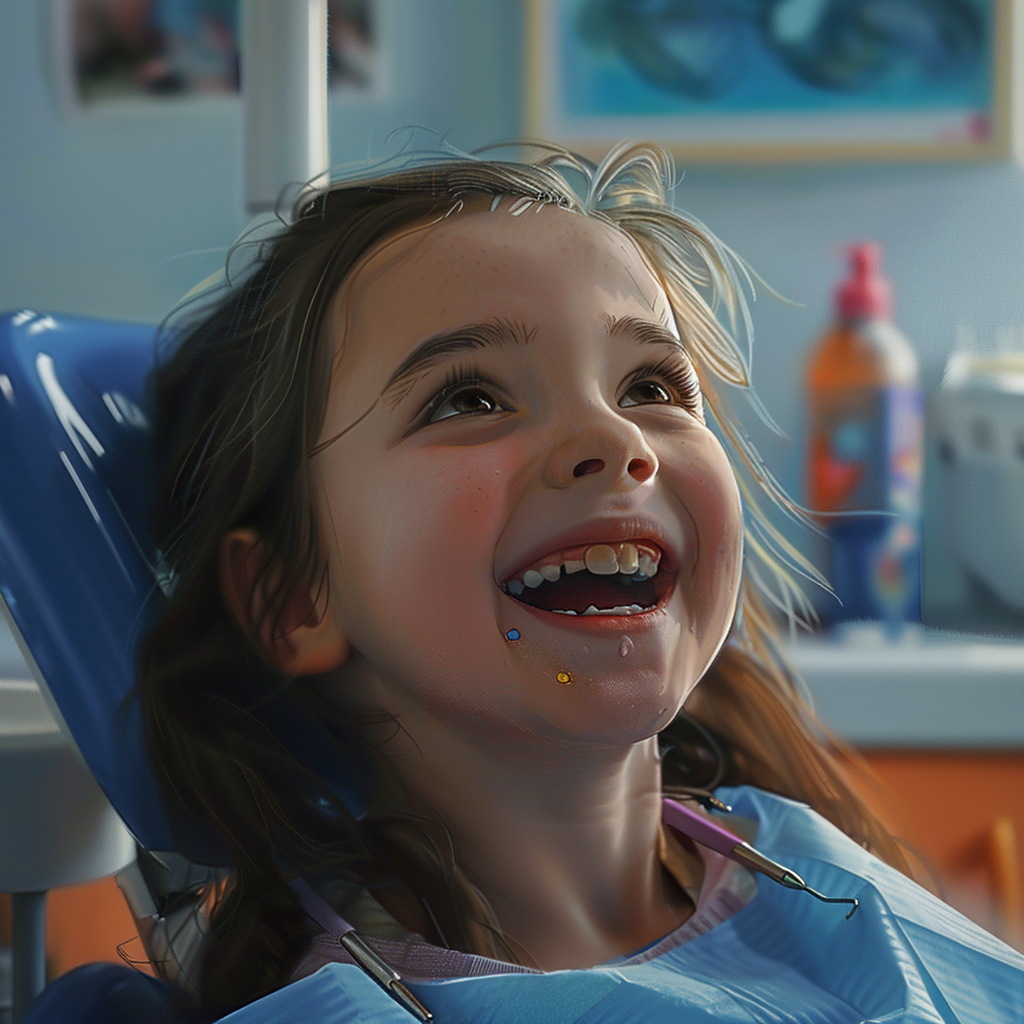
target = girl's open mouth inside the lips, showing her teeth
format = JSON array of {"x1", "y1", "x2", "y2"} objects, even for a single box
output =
[{"x1": 499, "y1": 542, "x2": 672, "y2": 615}]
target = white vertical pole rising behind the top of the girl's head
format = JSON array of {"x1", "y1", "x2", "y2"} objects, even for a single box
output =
[{"x1": 241, "y1": 0, "x2": 331, "y2": 213}]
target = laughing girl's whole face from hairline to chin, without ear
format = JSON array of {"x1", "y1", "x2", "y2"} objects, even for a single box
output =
[{"x1": 312, "y1": 199, "x2": 741, "y2": 745}]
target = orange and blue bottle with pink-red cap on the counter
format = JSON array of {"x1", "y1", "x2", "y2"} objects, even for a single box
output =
[{"x1": 806, "y1": 243, "x2": 924, "y2": 623}]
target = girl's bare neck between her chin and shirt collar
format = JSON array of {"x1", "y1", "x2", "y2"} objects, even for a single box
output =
[{"x1": 356, "y1": 688, "x2": 692, "y2": 970}]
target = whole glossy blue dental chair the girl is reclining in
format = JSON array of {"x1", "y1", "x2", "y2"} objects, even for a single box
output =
[{"x1": 0, "y1": 310, "x2": 372, "y2": 1024}]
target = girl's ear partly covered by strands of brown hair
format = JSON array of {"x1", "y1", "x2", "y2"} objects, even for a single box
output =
[{"x1": 220, "y1": 529, "x2": 348, "y2": 676}]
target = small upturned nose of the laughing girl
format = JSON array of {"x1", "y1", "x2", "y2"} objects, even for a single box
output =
[{"x1": 544, "y1": 411, "x2": 658, "y2": 490}]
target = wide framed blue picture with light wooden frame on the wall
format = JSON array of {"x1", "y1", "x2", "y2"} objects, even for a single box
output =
[{"x1": 524, "y1": 0, "x2": 1013, "y2": 163}]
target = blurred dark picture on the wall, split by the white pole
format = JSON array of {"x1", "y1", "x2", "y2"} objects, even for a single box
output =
[{"x1": 52, "y1": 0, "x2": 382, "y2": 110}]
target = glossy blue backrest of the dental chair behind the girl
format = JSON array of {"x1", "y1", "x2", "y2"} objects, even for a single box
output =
[{"x1": 0, "y1": 309, "x2": 174, "y2": 850}]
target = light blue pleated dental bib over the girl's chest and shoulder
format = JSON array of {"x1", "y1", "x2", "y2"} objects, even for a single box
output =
[{"x1": 223, "y1": 786, "x2": 1024, "y2": 1024}]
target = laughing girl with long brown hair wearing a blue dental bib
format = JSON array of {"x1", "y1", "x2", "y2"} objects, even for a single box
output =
[{"x1": 139, "y1": 146, "x2": 1024, "y2": 1021}]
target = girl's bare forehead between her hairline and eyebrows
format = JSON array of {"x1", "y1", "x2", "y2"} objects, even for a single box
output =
[{"x1": 328, "y1": 198, "x2": 671, "y2": 362}]
